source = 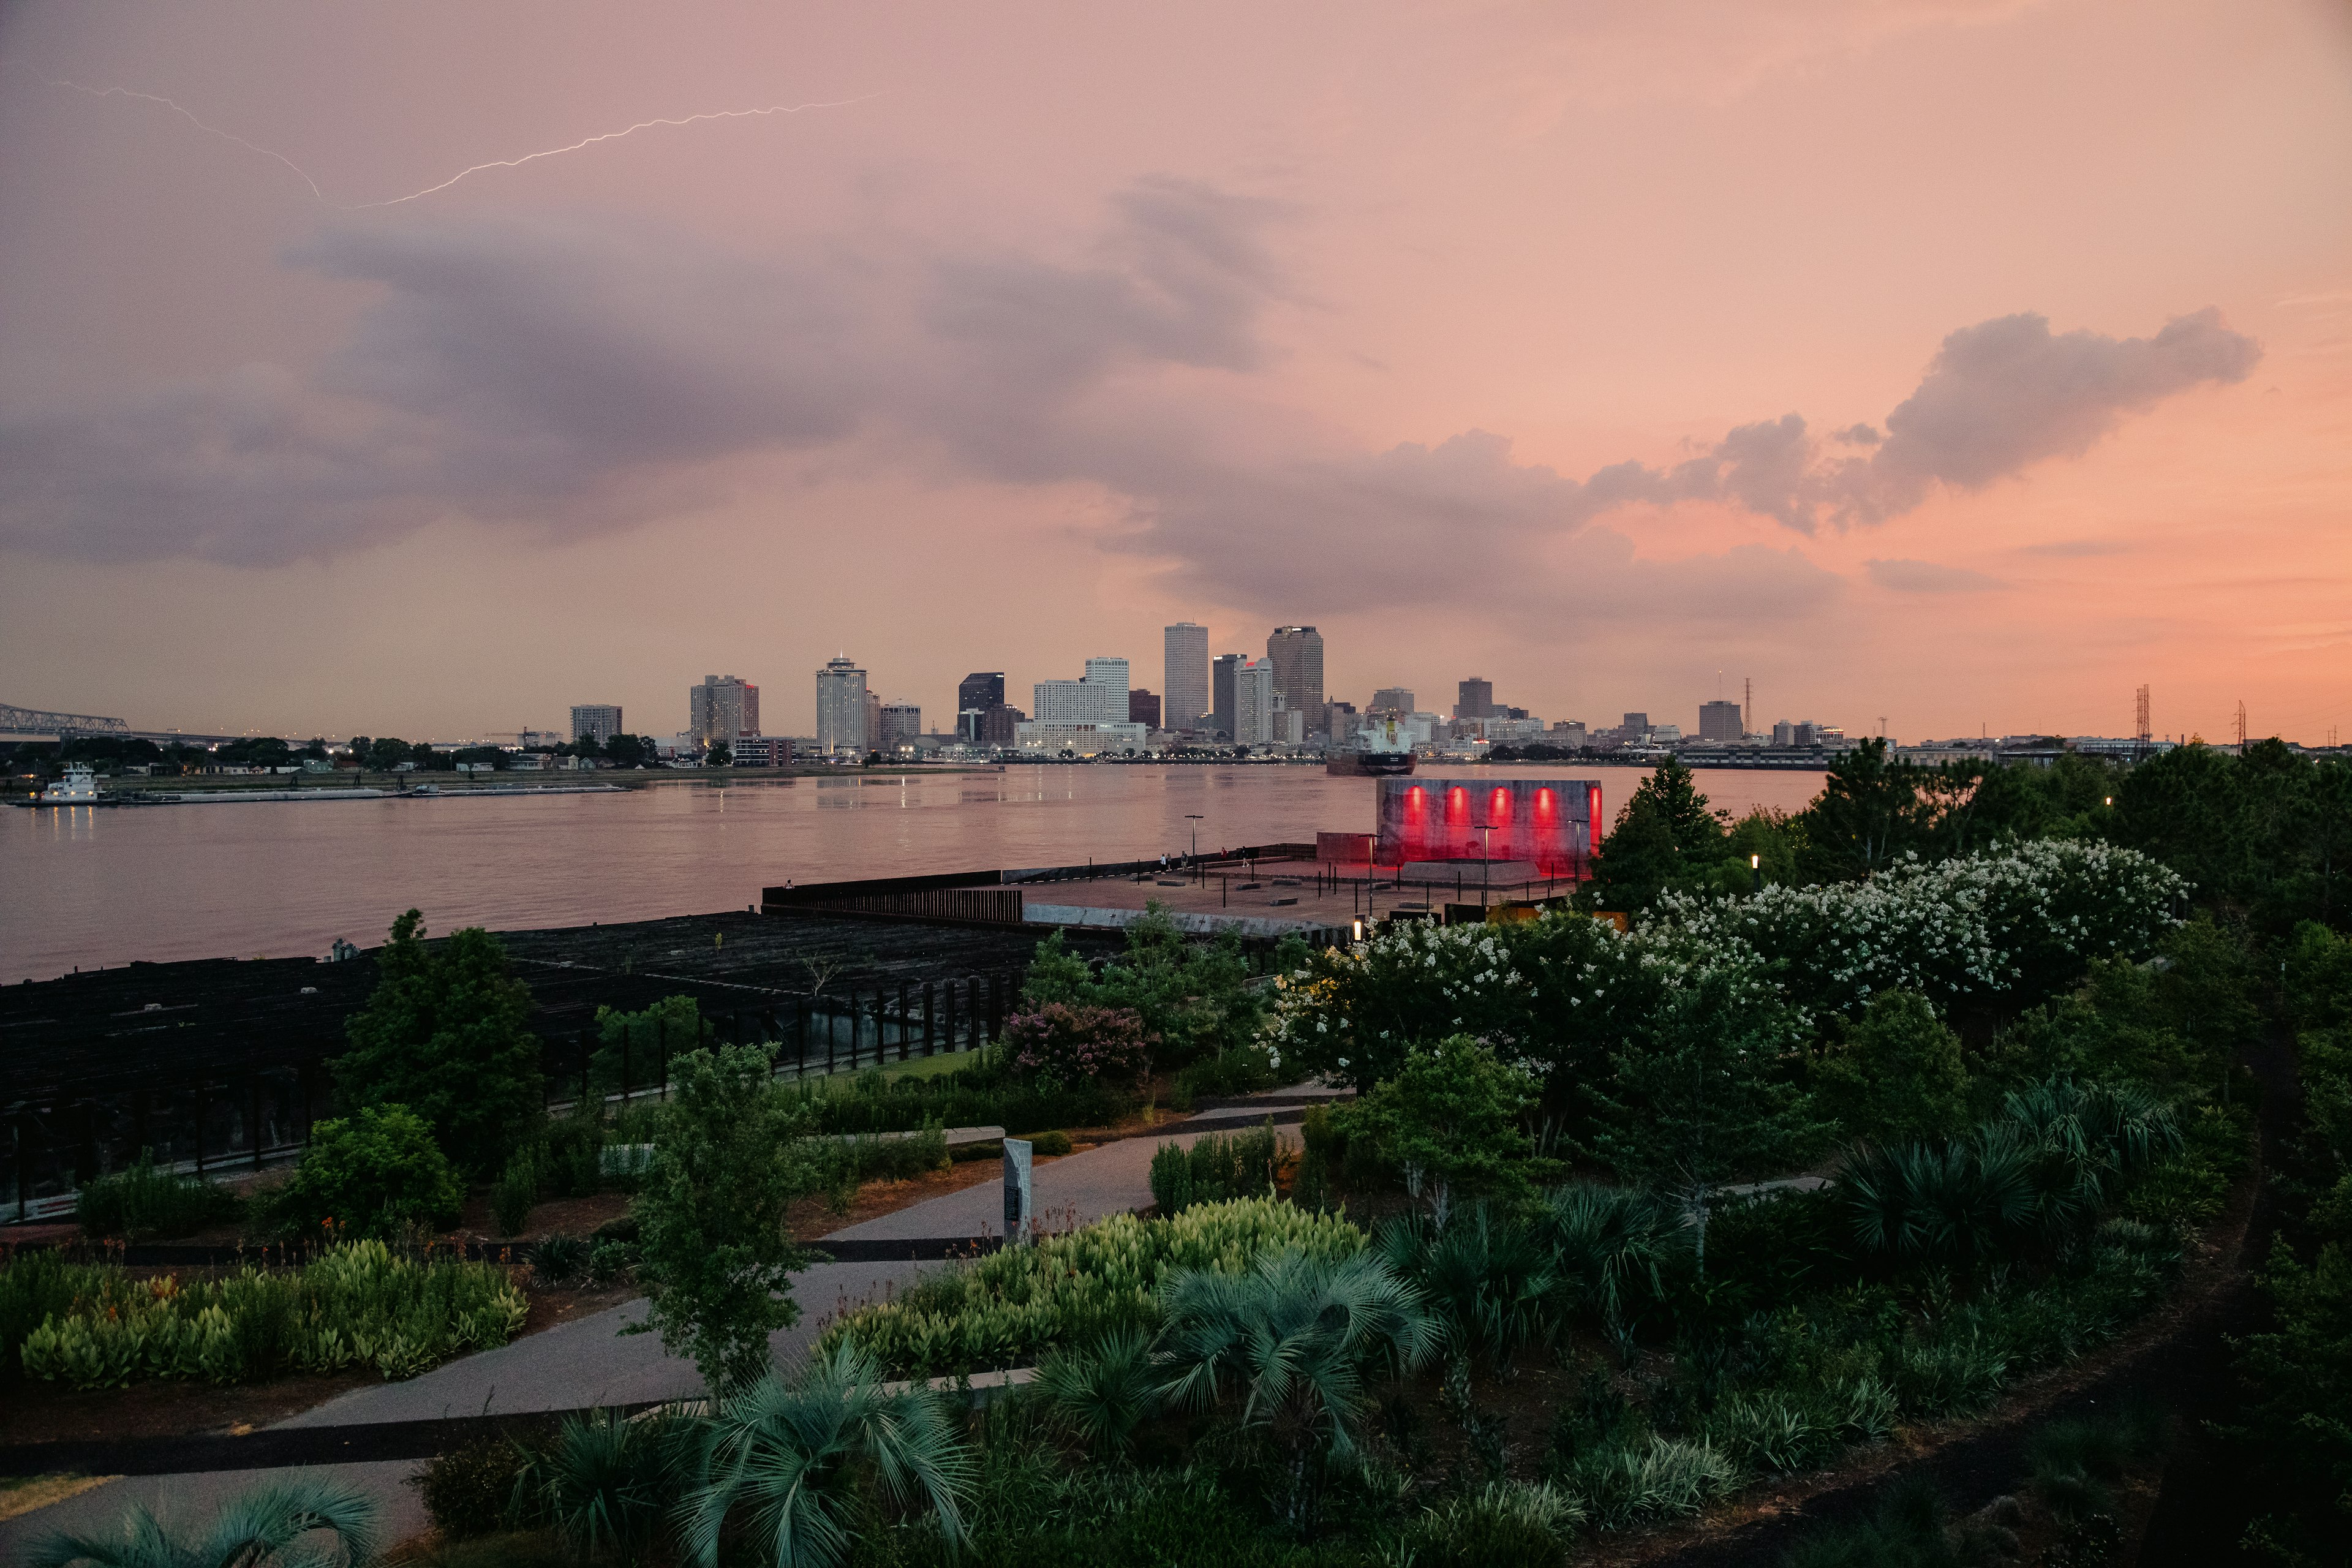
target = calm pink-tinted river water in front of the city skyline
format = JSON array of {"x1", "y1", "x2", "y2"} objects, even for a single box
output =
[{"x1": 0, "y1": 764, "x2": 1820, "y2": 982}]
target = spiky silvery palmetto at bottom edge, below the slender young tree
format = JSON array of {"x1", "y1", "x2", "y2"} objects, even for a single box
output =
[{"x1": 682, "y1": 1344, "x2": 971, "y2": 1568}]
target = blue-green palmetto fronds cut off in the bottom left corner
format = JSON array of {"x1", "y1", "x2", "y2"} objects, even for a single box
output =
[{"x1": 21, "y1": 1476, "x2": 379, "y2": 1568}]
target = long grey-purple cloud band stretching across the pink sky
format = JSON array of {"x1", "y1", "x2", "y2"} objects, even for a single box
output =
[{"x1": 0, "y1": 179, "x2": 2260, "y2": 618}]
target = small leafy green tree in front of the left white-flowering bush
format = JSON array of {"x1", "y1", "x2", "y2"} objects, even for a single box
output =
[{"x1": 1336, "y1": 1035, "x2": 1536, "y2": 1192}]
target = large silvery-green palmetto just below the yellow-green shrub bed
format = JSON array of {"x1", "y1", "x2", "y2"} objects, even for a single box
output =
[{"x1": 1159, "y1": 1251, "x2": 1439, "y2": 1458}]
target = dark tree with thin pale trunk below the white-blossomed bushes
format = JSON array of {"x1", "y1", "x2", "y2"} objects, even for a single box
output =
[{"x1": 1590, "y1": 964, "x2": 1828, "y2": 1272}]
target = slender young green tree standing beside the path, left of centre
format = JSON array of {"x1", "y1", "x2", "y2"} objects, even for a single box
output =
[{"x1": 638, "y1": 1044, "x2": 826, "y2": 1394}]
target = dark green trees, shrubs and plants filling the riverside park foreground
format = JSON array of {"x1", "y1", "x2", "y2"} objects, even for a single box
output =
[{"x1": 0, "y1": 743, "x2": 2352, "y2": 1568}]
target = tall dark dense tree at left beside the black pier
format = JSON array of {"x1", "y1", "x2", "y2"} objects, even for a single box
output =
[{"x1": 330, "y1": 910, "x2": 541, "y2": 1173}]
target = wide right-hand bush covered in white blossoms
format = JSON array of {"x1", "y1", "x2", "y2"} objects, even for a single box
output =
[{"x1": 1635, "y1": 842, "x2": 2187, "y2": 1013}]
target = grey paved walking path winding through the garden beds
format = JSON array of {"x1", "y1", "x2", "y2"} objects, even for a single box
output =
[{"x1": 0, "y1": 1088, "x2": 1315, "y2": 1561}]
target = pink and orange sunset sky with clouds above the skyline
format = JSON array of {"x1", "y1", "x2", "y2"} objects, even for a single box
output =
[{"x1": 0, "y1": 0, "x2": 2352, "y2": 743}]
